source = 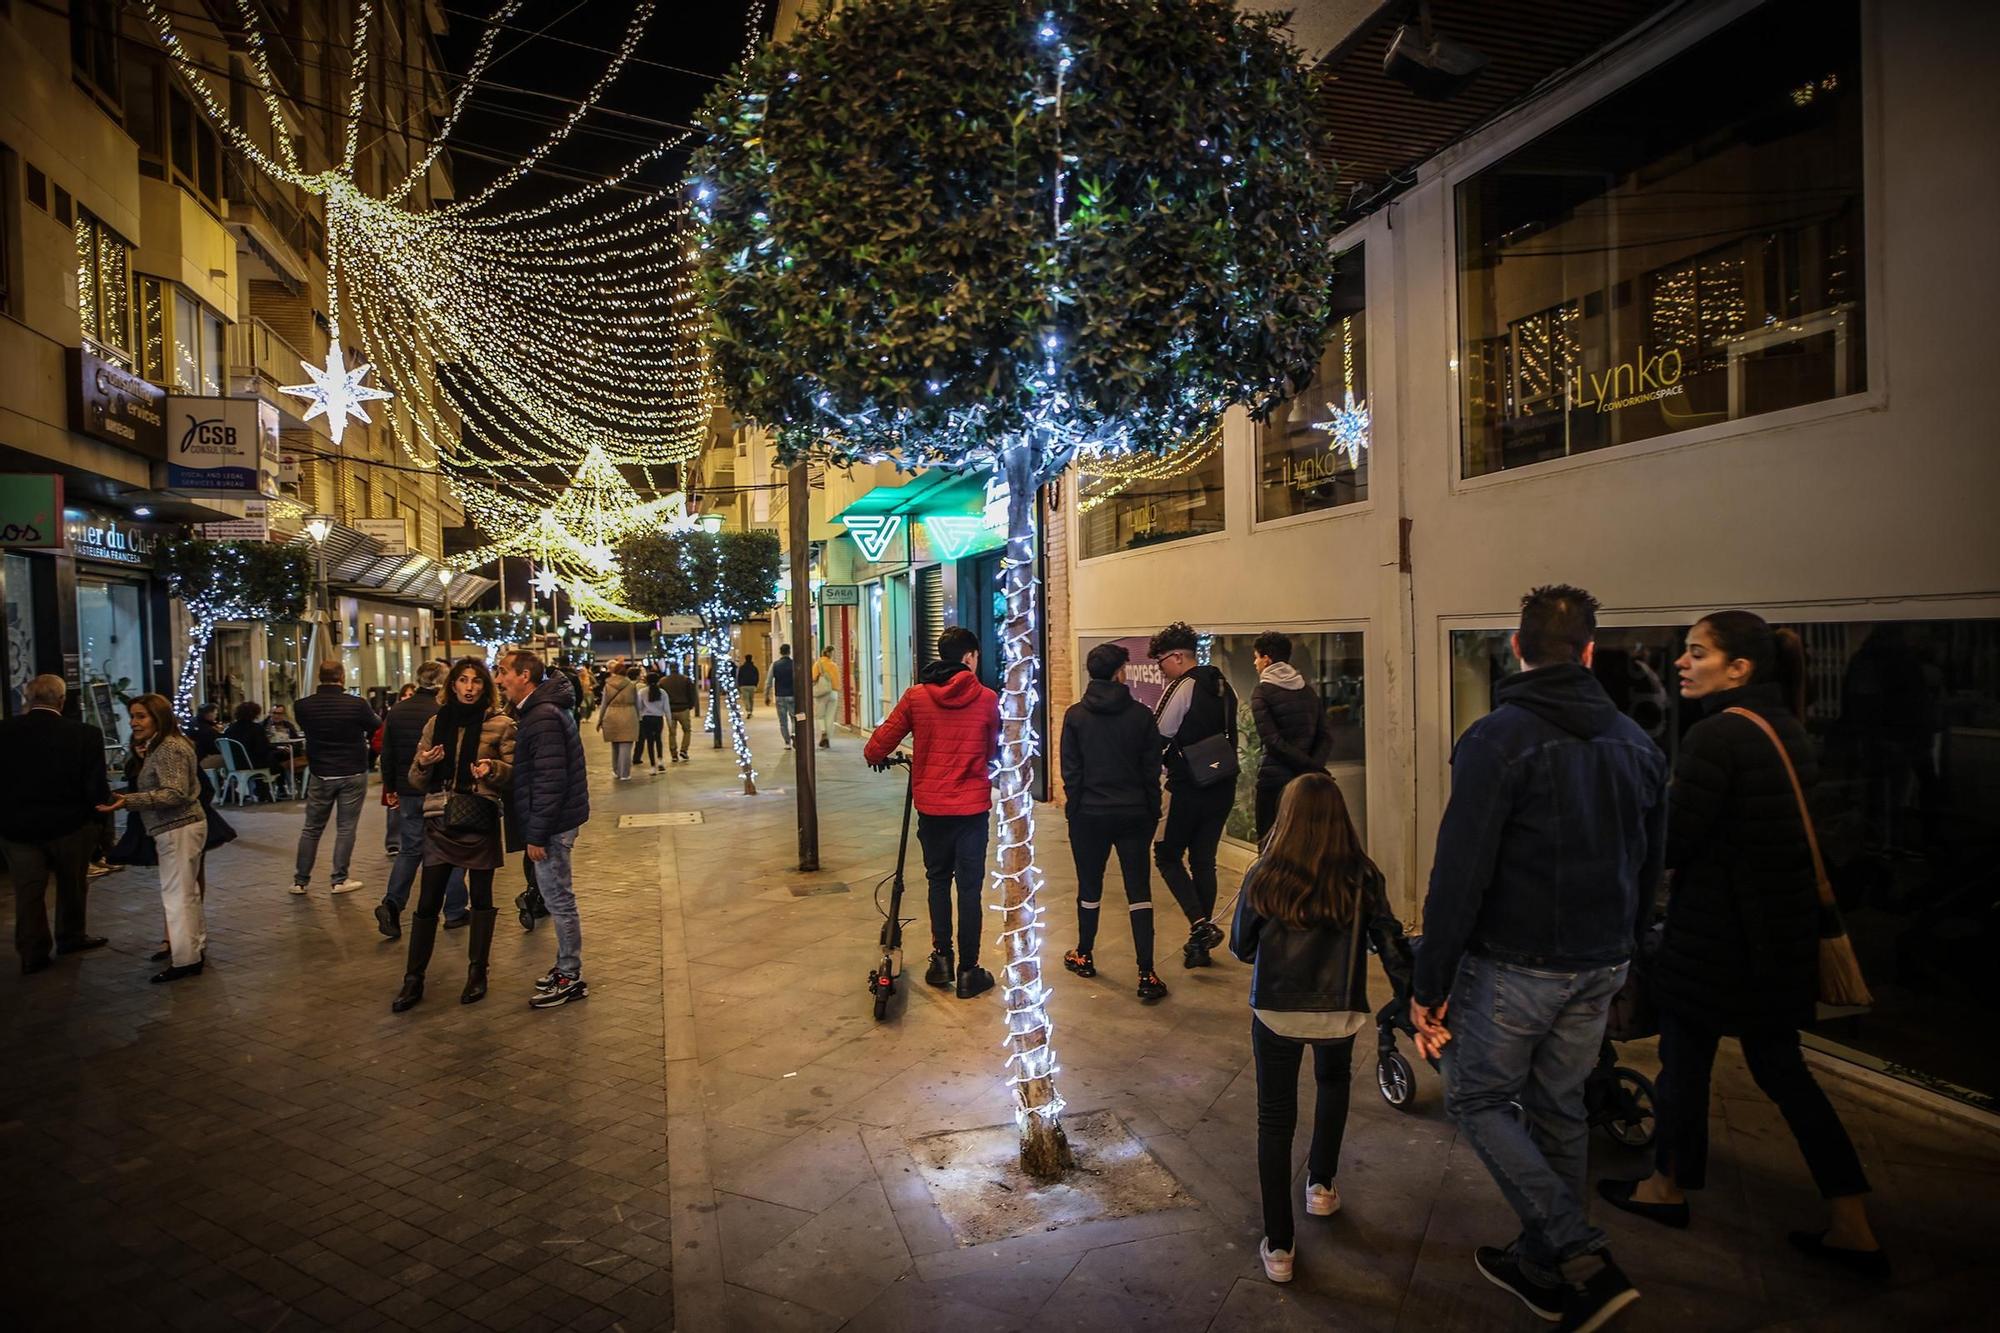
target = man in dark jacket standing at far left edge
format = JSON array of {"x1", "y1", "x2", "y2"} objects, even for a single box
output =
[{"x1": 0, "y1": 675, "x2": 112, "y2": 975}]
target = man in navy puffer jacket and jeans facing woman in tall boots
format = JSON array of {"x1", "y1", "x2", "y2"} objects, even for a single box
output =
[{"x1": 496, "y1": 650, "x2": 590, "y2": 1009}]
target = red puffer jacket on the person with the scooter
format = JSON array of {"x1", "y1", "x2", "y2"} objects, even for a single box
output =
[{"x1": 862, "y1": 662, "x2": 1000, "y2": 815}]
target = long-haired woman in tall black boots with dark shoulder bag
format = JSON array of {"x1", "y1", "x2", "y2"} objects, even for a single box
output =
[{"x1": 390, "y1": 656, "x2": 514, "y2": 1013}]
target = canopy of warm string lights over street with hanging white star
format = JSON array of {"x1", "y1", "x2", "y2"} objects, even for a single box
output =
[{"x1": 142, "y1": 0, "x2": 766, "y2": 588}]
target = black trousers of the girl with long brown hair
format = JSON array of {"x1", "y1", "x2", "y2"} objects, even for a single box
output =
[{"x1": 1250, "y1": 1017, "x2": 1354, "y2": 1249}]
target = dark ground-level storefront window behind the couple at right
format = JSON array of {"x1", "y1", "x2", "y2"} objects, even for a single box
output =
[{"x1": 1452, "y1": 620, "x2": 2000, "y2": 1107}]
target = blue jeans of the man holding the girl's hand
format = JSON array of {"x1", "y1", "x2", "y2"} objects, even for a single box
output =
[{"x1": 1444, "y1": 955, "x2": 1628, "y2": 1283}]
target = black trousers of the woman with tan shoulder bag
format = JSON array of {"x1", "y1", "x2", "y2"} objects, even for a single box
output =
[{"x1": 1652, "y1": 1009, "x2": 1868, "y2": 1199}]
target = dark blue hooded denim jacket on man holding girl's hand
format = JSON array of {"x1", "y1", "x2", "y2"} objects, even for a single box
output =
[{"x1": 1416, "y1": 664, "x2": 1668, "y2": 1005}]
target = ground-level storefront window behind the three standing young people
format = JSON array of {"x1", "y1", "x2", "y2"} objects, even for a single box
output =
[{"x1": 1054, "y1": 630, "x2": 1368, "y2": 843}]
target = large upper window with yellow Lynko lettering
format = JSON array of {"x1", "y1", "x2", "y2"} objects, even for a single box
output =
[{"x1": 1458, "y1": 0, "x2": 1868, "y2": 476}]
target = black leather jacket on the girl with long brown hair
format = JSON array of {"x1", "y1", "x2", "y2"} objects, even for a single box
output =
[{"x1": 1230, "y1": 865, "x2": 1410, "y2": 1013}]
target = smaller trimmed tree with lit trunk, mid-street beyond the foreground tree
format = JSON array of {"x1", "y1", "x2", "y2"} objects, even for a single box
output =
[{"x1": 618, "y1": 526, "x2": 780, "y2": 797}]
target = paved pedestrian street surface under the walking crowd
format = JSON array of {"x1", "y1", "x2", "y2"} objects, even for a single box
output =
[{"x1": 0, "y1": 713, "x2": 2000, "y2": 1333}]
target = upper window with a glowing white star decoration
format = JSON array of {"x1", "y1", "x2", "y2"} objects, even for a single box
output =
[{"x1": 1256, "y1": 246, "x2": 1374, "y2": 520}]
